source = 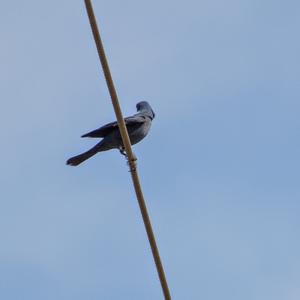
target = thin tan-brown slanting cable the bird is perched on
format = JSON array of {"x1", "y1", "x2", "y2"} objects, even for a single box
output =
[{"x1": 84, "y1": 0, "x2": 171, "y2": 300}]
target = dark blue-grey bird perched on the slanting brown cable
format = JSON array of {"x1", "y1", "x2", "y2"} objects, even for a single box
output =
[{"x1": 66, "y1": 101, "x2": 155, "y2": 166}]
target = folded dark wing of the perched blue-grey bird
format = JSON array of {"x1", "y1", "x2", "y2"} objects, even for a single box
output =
[{"x1": 81, "y1": 114, "x2": 145, "y2": 138}]
